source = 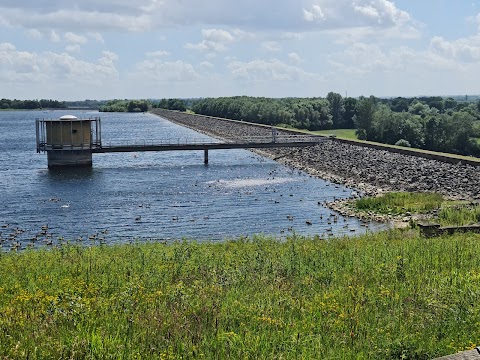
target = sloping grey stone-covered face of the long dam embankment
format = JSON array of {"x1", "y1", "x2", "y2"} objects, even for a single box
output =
[{"x1": 153, "y1": 109, "x2": 480, "y2": 200}]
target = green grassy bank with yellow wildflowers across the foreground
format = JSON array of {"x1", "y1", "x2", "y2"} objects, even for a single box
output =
[{"x1": 0, "y1": 231, "x2": 480, "y2": 359}]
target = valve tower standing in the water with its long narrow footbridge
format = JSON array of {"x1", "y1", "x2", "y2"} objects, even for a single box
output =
[{"x1": 36, "y1": 115, "x2": 325, "y2": 168}]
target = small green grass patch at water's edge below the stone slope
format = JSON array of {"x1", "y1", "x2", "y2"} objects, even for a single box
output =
[{"x1": 354, "y1": 192, "x2": 443, "y2": 215}]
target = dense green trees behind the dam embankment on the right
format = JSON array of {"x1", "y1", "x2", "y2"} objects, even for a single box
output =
[{"x1": 192, "y1": 92, "x2": 480, "y2": 156}]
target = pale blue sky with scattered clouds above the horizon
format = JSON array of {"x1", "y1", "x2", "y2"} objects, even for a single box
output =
[{"x1": 0, "y1": 0, "x2": 480, "y2": 101}]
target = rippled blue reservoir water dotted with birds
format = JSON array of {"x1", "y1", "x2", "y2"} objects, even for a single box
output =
[{"x1": 0, "y1": 111, "x2": 383, "y2": 250}]
